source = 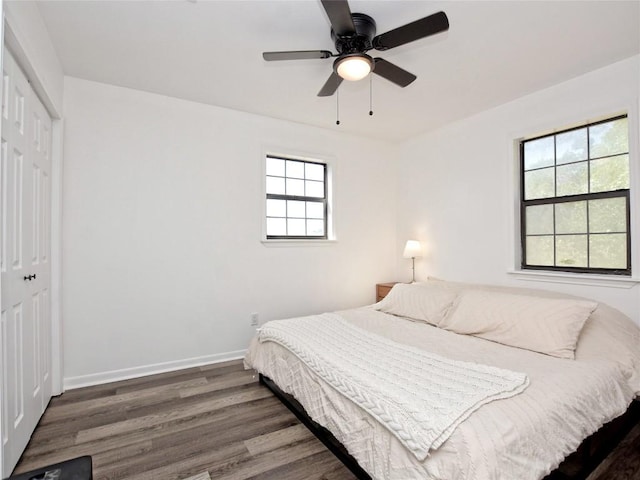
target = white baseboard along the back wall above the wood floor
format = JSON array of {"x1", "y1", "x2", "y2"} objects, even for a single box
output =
[{"x1": 63, "y1": 350, "x2": 246, "y2": 390}]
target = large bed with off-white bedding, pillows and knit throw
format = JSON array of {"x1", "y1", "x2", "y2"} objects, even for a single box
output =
[{"x1": 245, "y1": 281, "x2": 640, "y2": 480}]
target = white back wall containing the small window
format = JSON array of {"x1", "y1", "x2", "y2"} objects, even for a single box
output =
[{"x1": 63, "y1": 77, "x2": 396, "y2": 386}]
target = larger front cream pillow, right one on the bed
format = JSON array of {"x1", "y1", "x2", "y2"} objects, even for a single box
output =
[{"x1": 439, "y1": 290, "x2": 598, "y2": 359}]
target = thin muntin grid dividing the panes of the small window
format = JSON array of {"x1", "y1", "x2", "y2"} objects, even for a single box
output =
[{"x1": 265, "y1": 155, "x2": 329, "y2": 240}]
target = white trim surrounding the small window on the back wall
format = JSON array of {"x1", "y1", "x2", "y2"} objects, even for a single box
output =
[{"x1": 259, "y1": 147, "x2": 337, "y2": 247}]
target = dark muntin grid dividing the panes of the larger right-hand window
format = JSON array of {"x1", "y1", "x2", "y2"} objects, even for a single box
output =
[{"x1": 520, "y1": 115, "x2": 631, "y2": 275}]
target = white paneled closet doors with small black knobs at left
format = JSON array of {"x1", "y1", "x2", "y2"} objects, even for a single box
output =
[{"x1": 0, "y1": 49, "x2": 51, "y2": 476}]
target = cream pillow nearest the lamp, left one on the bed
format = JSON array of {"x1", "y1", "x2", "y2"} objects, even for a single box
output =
[{"x1": 375, "y1": 283, "x2": 457, "y2": 325}]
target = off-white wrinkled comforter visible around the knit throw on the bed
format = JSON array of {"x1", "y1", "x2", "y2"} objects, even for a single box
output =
[{"x1": 245, "y1": 284, "x2": 640, "y2": 480}]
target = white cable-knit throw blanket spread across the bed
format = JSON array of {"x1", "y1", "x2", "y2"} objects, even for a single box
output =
[{"x1": 258, "y1": 313, "x2": 529, "y2": 460}]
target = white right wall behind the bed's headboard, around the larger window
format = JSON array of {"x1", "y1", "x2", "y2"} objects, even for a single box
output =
[{"x1": 397, "y1": 56, "x2": 640, "y2": 323}]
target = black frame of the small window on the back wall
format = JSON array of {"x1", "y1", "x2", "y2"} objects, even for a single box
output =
[{"x1": 262, "y1": 153, "x2": 331, "y2": 243}]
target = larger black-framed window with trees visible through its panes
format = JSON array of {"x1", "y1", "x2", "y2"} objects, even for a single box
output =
[{"x1": 520, "y1": 116, "x2": 631, "y2": 275}]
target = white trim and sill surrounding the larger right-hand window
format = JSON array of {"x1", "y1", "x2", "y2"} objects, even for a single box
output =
[{"x1": 505, "y1": 98, "x2": 640, "y2": 288}]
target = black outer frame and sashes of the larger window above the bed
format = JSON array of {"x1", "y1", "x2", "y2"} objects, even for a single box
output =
[{"x1": 518, "y1": 113, "x2": 633, "y2": 277}]
